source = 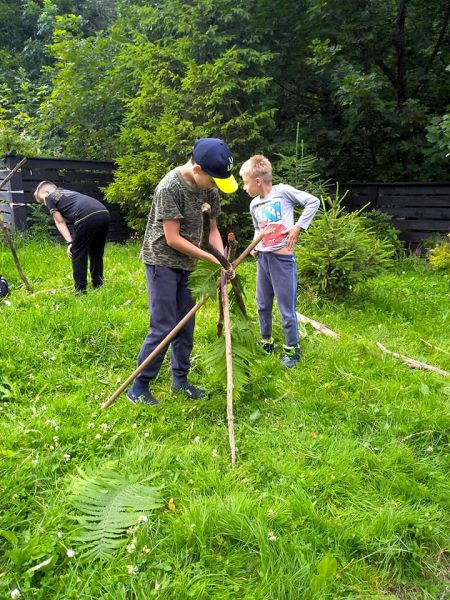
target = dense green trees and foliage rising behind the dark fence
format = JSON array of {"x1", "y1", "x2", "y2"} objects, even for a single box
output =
[{"x1": 0, "y1": 0, "x2": 450, "y2": 225}]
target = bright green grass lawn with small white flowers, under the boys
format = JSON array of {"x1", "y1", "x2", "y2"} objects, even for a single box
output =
[{"x1": 0, "y1": 239, "x2": 450, "y2": 600}]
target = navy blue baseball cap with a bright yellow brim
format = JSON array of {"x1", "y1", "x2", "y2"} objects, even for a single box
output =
[{"x1": 192, "y1": 138, "x2": 238, "y2": 194}]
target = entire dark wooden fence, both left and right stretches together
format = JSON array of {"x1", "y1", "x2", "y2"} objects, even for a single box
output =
[{"x1": 0, "y1": 156, "x2": 450, "y2": 248}]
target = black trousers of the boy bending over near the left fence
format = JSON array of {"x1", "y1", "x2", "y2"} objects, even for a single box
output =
[{"x1": 71, "y1": 211, "x2": 111, "y2": 292}]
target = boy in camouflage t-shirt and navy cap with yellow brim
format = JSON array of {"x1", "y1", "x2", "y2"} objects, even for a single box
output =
[{"x1": 127, "y1": 138, "x2": 237, "y2": 404}]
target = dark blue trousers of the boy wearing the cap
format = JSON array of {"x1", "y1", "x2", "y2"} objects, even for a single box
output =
[{"x1": 136, "y1": 265, "x2": 195, "y2": 384}]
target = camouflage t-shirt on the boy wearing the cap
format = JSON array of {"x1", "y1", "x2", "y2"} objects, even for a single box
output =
[{"x1": 141, "y1": 168, "x2": 220, "y2": 271}]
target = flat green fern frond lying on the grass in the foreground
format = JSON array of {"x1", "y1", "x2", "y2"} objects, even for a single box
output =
[{"x1": 69, "y1": 466, "x2": 163, "y2": 559}]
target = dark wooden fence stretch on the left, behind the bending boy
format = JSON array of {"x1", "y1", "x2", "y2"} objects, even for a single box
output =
[{"x1": 0, "y1": 155, "x2": 131, "y2": 242}]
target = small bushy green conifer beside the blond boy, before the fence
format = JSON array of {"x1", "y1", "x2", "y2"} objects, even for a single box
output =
[{"x1": 298, "y1": 190, "x2": 395, "y2": 297}]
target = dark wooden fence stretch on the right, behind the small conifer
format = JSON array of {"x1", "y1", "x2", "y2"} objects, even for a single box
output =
[{"x1": 340, "y1": 183, "x2": 450, "y2": 248}]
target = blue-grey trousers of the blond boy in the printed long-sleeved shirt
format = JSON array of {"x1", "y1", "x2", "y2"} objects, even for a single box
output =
[{"x1": 256, "y1": 252, "x2": 298, "y2": 346}]
